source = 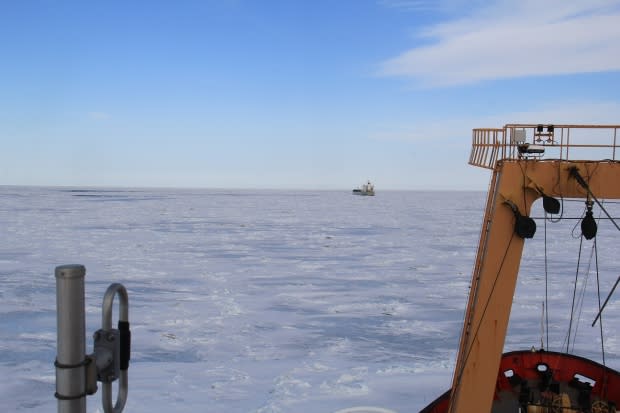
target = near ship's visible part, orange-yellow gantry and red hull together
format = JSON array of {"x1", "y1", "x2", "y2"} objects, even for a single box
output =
[{"x1": 422, "y1": 124, "x2": 620, "y2": 413}]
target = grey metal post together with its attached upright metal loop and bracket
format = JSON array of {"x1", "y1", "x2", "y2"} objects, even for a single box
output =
[{"x1": 54, "y1": 264, "x2": 131, "y2": 413}]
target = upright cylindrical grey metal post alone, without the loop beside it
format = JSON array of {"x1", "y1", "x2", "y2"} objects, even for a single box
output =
[{"x1": 55, "y1": 264, "x2": 86, "y2": 413}]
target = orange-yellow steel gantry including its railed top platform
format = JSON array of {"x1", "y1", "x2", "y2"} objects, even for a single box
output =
[{"x1": 449, "y1": 124, "x2": 620, "y2": 413}]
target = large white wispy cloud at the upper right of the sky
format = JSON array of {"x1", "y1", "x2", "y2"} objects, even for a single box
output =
[{"x1": 381, "y1": 0, "x2": 620, "y2": 86}]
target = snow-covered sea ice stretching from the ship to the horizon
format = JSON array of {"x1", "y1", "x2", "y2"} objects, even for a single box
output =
[{"x1": 0, "y1": 187, "x2": 620, "y2": 413}]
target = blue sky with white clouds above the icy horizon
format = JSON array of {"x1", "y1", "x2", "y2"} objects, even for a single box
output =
[{"x1": 0, "y1": 0, "x2": 620, "y2": 190}]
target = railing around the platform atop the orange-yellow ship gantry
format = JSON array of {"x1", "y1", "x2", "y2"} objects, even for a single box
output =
[{"x1": 469, "y1": 124, "x2": 620, "y2": 169}]
